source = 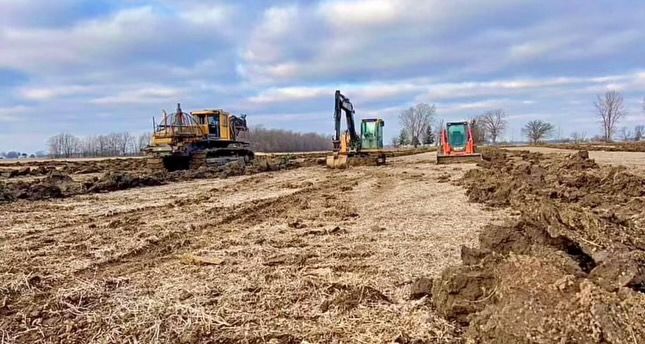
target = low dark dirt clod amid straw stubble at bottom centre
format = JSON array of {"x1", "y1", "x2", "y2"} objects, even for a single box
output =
[{"x1": 320, "y1": 284, "x2": 392, "y2": 312}]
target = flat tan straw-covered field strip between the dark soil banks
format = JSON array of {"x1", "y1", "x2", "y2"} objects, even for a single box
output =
[{"x1": 0, "y1": 153, "x2": 506, "y2": 343}]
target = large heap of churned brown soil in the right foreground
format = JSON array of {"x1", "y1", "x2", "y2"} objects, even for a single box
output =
[{"x1": 432, "y1": 151, "x2": 645, "y2": 343}]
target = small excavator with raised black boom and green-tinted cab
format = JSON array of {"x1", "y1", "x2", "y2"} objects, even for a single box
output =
[{"x1": 327, "y1": 90, "x2": 385, "y2": 168}]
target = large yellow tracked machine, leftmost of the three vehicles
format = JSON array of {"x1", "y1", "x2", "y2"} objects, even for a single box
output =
[{"x1": 144, "y1": 104, "x2": 254, "y2": 171}]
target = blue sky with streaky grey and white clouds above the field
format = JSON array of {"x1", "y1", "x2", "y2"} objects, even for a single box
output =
[{"x1": 0, "y1": 0, "x2": 645, "y2": 152}]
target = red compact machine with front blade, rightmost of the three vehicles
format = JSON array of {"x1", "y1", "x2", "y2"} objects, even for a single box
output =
[{"x1": 437, "y1": 122, "x2": 482, "y2": 164}]
